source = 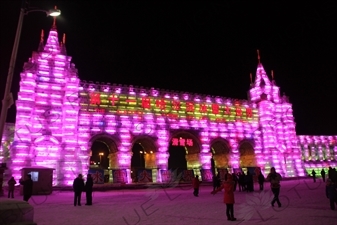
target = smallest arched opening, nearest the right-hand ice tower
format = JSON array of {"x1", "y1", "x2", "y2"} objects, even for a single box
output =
[{"x1": 239, "y1": 141, "x2": 257, "y2": 168}]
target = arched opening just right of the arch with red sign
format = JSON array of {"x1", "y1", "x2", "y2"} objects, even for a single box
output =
[{"x1": 211, "y1": 138, "x2": 230, "y2": 175}]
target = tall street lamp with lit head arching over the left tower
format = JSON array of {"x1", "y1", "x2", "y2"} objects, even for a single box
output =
[{"x1": 0, "y1": 1, "x2": 61, "y2": 160}]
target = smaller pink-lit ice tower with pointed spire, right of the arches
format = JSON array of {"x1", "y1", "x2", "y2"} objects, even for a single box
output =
[{"x1": 249, "y1": 52, "x2": 304, "y2": 177}]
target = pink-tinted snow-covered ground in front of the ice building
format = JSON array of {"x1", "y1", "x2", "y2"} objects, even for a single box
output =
[{"x1": 0, "y1": 179, "x2": 337, "y2": 225}]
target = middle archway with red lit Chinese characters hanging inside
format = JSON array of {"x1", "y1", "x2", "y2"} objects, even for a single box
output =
[{"x1": 168, "y1": 131, "x2": 201, "y2": 176}]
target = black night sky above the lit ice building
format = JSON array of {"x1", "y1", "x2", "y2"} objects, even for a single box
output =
[{"x1": 0, "y1": 0, "x2": 337, "y2": 135}]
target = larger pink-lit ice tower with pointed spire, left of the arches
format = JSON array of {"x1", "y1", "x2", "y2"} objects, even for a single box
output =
[{"x1": 9, "y1": 19, "x2": 83, "y2": 185}]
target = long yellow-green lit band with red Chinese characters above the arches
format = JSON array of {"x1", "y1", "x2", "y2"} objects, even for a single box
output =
[{"x1": 80, "y1": 91, "x2": 258, "y2": 122}]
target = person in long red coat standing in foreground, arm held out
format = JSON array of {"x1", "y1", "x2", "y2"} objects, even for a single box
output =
[{"x1": 211, "y1": 174, "x2": 236, "y2": 221}]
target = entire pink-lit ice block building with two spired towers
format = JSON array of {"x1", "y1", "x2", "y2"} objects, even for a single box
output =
[{"x1": 1, "y1": 26, "x2": 337, "y2": 186}]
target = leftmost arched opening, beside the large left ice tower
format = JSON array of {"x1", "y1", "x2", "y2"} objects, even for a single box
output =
[{"x1": 89, "y1": 134, "x2": 118, "y2": 183}]
